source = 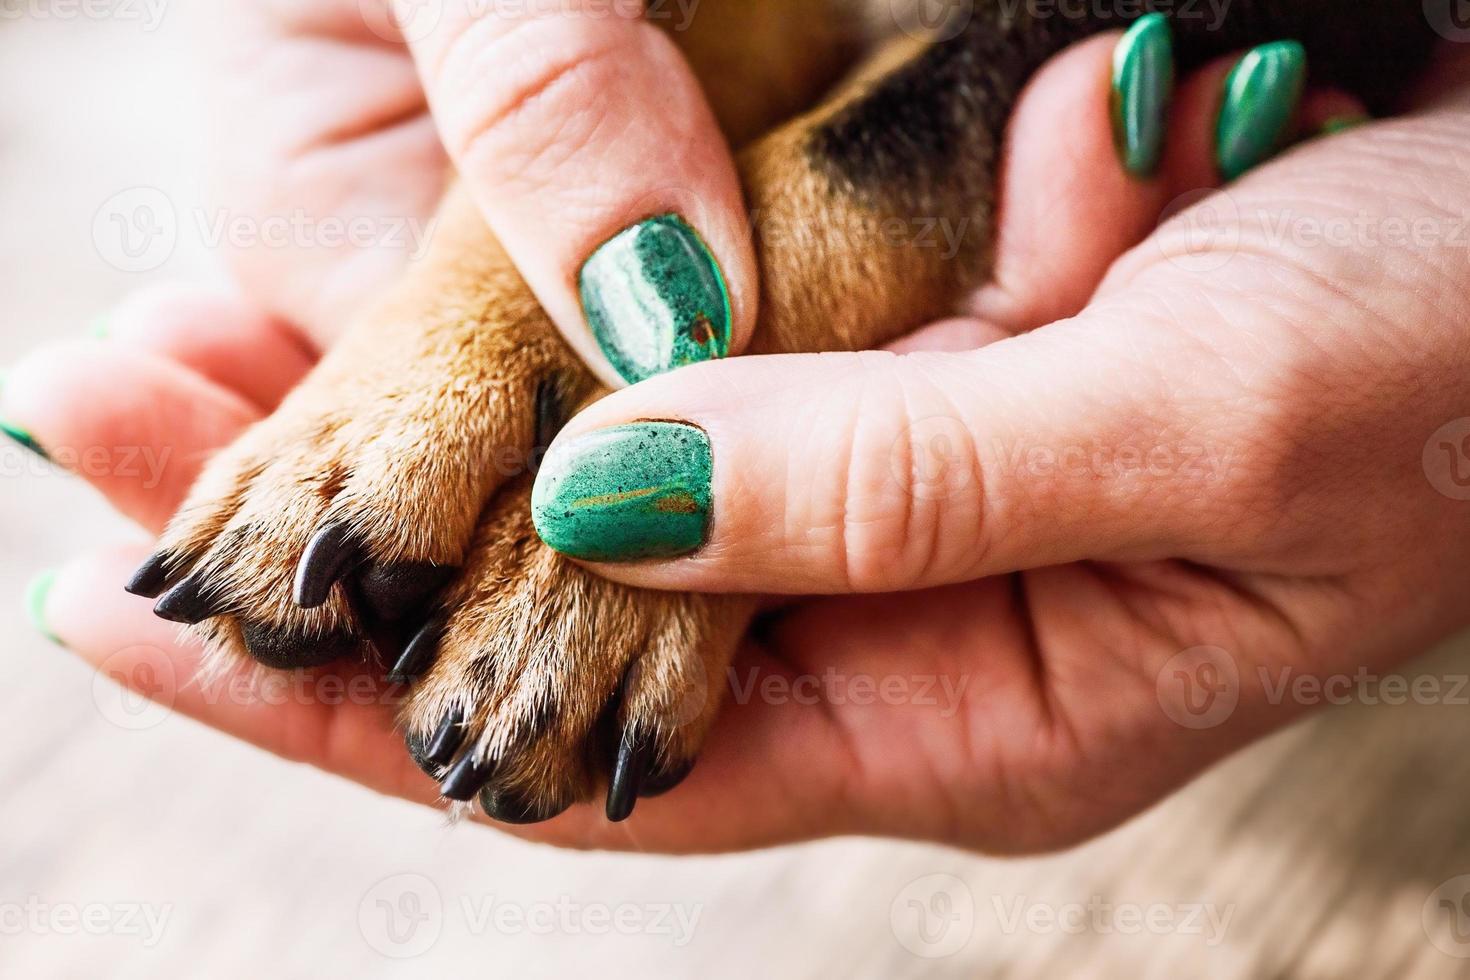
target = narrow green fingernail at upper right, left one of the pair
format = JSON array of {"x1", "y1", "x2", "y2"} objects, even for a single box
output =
[{"x1": 1113, "y1": 13, "x2": 1175, "y2": 178}]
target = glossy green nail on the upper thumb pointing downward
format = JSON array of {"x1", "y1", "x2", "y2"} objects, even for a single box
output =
[{"x1": 579, "y1": 215, "x2": 731, "y2": 383}]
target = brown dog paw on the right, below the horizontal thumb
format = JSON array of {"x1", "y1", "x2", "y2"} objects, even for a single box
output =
[{"x1": 401, "y1": 479, "x2": 748, "y2": 824}]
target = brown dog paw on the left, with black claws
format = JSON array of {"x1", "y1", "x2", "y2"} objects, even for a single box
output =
[{"x1": 128, "y1": 257, "x2": 591, "y2": 669}]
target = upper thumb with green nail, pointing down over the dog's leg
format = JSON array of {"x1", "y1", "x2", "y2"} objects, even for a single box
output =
[{"x1": 404, "y1": 0, "x2": 756, "y2": 385}]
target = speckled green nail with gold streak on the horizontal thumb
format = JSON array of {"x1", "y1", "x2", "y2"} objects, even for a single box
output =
[{"x1": 531, "y1": 422, "x2": 714, "y2": 561}]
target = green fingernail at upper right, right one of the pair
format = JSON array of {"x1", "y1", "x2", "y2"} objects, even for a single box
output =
[{"x1": 1216, "y1": 41, "x2": 1307, "y2": 181}]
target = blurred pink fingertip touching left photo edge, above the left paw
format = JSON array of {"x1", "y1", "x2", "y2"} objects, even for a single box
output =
[{"x1": 0, "y1": 342, "x2": 260, "y2": 532}]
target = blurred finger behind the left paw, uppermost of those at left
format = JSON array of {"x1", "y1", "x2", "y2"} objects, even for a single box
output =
[{"x1": 101, "y1": 284, "x2": 313, "y2": 411}]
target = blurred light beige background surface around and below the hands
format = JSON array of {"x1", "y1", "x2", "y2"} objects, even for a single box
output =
[{"x1": 0, "y1": 9, "x2": 1470, "y2": 979}]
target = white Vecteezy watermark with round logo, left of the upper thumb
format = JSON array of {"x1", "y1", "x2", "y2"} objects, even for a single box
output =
[{"x1": 93, "y1": 187, "x2": 434, "y2": 272}]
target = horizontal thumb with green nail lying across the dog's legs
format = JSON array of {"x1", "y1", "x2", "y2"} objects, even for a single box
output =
[{"x1": 532, "y1": 307, "x2": 1222, "y2": 594}]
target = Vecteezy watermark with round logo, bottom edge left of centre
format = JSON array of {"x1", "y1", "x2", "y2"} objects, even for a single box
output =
[{"x1": 357, "y1": 873, "x2": 704, "y2": 959}]
